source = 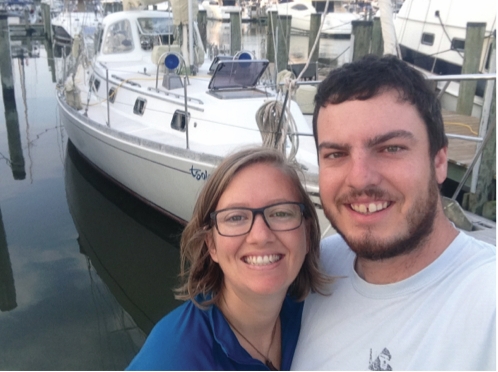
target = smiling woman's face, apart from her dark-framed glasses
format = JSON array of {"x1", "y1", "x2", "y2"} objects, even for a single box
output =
[{"x1": 207, "y1": 163, "x2": 308, "y2": 296}]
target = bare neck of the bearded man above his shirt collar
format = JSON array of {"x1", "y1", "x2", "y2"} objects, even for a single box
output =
[{"x1": 355, "y1": 217, "x2": 458, "y2": 284}]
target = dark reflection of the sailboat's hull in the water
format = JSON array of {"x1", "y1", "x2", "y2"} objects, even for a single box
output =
[{"x1": 65, "y1": 142, "x2": 183, "y2": 338}]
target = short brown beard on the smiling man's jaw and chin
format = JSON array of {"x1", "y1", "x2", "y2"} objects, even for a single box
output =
[{"x1": 322, "y1": 169, "x2": 439, "y2": 261}]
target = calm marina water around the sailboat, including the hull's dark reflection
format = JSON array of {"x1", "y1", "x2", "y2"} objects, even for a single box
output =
[{"x1": 0, "y1": 19, "x2": 349, "y2": 370}]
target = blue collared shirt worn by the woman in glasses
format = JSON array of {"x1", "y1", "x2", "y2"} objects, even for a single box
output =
[{"x1": 127, "y1": 296, "x2": 304, "y2": 371}]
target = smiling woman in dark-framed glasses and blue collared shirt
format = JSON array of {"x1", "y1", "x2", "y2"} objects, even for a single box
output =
[{"x1": 128, "y1": 148, "x2": 329, "y2": 370}]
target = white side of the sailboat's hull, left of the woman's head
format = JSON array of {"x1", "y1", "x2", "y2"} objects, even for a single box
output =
[{"x1": 59, "y1": 93, "x2": 212, "y2": 222}]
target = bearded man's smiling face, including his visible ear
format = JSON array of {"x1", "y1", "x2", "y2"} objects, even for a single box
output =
[{"x1": 317, "y1": 91, "x2": 447, "y2": 260}]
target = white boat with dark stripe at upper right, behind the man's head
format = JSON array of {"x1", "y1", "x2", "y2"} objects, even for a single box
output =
[{"x1": 394, "y1": 0, "x2": 496, "y2": 117}]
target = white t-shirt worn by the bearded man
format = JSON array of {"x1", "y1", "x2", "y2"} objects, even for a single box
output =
[{"x1": 292, "y1": 233, "x2": 496, "y2": 370}]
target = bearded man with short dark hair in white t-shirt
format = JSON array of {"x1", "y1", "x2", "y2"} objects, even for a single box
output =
[{"x1": 292, "y1": 56, "x2": 496, "y2": 370}]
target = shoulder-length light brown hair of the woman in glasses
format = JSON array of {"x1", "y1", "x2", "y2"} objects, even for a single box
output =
[{"x1": 176, "y1": 147, "x2": 330, "y2": 306}]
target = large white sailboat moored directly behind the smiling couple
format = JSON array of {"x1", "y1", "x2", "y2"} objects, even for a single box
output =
[{"x1": 57, "y1": 6, "x2": 333, "y2": 234}]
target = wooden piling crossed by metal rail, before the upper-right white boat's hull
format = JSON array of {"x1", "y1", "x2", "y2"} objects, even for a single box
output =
[{"x1": 456, "y1": 22, "x2": 486, "y2": 116}]
